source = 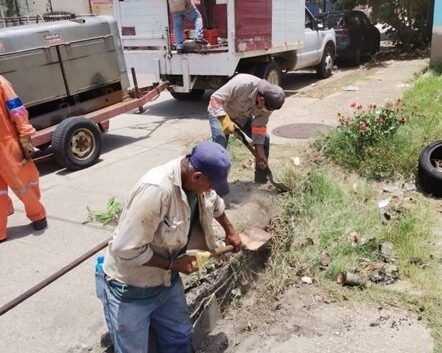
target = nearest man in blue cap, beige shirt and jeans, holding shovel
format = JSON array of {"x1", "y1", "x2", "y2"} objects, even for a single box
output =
[{"x1": 96, "y1": 142, "x2": 241, "y2": 353}]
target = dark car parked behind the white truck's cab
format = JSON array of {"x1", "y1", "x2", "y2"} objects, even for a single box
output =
[{"x1": 323, "y1": 10, "x2": 381, "y2": 65}]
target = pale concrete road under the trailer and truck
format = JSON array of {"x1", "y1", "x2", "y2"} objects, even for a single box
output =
[{"x1": 0, "y1": 56, "x2": 426, "y2": 353}]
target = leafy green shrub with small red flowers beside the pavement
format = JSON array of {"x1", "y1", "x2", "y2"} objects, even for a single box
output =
[{"x1": 318, "y1": 100, "x2": 412, "y2": 180}]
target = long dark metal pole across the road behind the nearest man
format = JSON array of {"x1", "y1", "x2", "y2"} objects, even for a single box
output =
[{"x1": 0, "y1": 238, "x2": 112, "y2": 316}]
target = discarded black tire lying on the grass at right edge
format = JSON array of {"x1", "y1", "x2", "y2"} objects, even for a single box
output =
[{"x1": 418, "y1": 140, "x2": 442, "y2": 197}]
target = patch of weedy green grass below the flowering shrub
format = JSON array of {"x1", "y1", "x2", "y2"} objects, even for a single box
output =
[{"x1": 263, "y1": 168, "x2": 442, "y2": 347}]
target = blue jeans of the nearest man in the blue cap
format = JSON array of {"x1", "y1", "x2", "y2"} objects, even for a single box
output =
[{"x1": 95, "y1": 273, "x2": 192, "y2": 353}]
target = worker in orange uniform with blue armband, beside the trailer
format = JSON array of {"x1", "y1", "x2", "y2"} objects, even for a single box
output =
[{"x1": 0, "y1": 75, "x2": 48, "y2": 241}]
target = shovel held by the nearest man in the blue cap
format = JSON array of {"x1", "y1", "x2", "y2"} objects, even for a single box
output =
[{"x1": 186, "y1": 228, "x2": 273, "y2": 267}]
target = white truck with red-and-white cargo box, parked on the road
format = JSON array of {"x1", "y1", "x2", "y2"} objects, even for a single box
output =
[{"x1": 114, "y1": 0, "x2": 336, "y2": 99}]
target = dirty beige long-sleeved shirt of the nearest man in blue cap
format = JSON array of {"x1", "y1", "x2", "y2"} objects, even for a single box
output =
[{"x1": 104, "y1": 157, "x2": 225, "y2": 287}]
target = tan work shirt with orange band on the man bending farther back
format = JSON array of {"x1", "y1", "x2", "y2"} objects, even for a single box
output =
[{"x1": 208, "y1": 74, "x2": 271, "y2": 145}]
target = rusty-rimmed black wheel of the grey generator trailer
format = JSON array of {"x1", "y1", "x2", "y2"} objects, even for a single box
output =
[{"x1": 52, "y1": 117, "x2": 101, "y2": 170}]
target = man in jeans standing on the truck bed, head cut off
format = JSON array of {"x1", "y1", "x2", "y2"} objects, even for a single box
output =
[{"x1": 168, "y1": 0, "x2": 206, "y2": 53}]
